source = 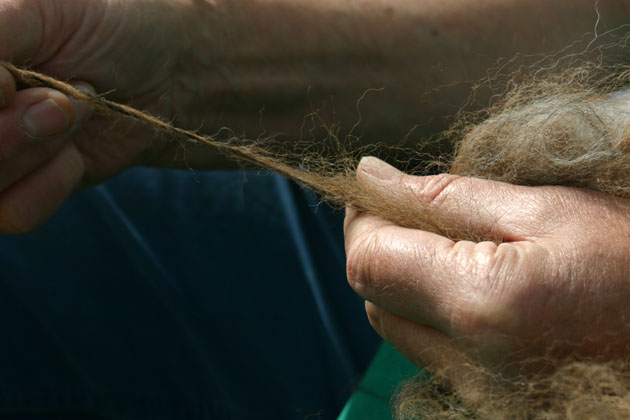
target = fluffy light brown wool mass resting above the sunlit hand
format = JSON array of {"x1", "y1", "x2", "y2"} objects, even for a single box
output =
[{"x1": 450, "y1": 76, "x2": 630, "y2": 197}]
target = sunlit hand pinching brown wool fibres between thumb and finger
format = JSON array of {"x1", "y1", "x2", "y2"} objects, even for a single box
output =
[{"x1": 345, "y1": 158, "x2": 630, "y2": 374}]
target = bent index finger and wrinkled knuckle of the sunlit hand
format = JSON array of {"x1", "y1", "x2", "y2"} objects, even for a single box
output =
[{"x1": 346, "y1": 209, "x2": 547, "y2": 336}]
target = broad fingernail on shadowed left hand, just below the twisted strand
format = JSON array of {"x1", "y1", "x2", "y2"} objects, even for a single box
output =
[{"x1": 22, "y1": 99, "x2": 70, "y2": 138}]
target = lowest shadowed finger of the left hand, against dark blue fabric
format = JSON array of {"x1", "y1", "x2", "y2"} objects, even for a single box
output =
[{"x1": 0, "y1": 143, "x2": 84, "y2": 233}]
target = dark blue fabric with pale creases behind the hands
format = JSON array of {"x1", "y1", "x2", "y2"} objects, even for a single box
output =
[{"x1": 0, "y1": 168, "x2": 379, "y2": 420}]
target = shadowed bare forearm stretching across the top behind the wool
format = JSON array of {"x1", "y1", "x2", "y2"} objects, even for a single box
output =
[{"x1": 159, "y1": 0, "x2": 627, "y2": 167}]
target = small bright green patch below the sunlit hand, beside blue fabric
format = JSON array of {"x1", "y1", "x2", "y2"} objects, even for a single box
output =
[{"x1": 337, "y1": 343, "x2": 422, "y2": 420}]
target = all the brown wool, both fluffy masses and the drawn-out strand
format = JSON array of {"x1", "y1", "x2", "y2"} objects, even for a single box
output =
[{"x1": 6, "y1": 62, "x2": 630, "y2": 420}]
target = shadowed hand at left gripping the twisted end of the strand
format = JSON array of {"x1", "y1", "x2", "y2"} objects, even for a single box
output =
[{"x1": 0, "y1": 0, "x2": 202, "y2": 233}]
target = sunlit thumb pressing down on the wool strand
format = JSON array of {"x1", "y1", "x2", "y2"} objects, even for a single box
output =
[{"x1": 357, "y1": 157, "x2": 560, "y2": 242}]
